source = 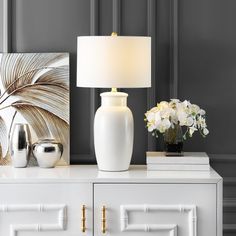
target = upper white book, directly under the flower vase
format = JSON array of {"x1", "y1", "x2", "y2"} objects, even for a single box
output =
[{"x1": 146, "y1": 152, "x2": 209, "y2": 165}]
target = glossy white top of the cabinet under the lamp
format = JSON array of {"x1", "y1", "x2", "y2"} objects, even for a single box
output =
[{"x1": 0, "y1": 165, "x2": 222, "y2": 183}]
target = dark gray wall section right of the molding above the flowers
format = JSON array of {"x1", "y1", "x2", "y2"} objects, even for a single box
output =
[{"x1": 178, "y1": 0, "x2": 236, "y2": 236}]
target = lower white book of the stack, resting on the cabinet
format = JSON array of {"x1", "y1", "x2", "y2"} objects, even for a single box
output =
[{"x1": 147, "y1": 164, "x2": 210, "y2": 171}]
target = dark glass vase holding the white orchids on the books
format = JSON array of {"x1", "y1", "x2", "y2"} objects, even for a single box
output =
[{"x1": 164, "y1": 124, "x2": 183, "y2": 156}]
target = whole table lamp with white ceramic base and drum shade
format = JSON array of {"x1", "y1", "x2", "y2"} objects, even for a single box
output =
[{"x1": 77, "y1": 33, "x2": 151, "y2": 171}]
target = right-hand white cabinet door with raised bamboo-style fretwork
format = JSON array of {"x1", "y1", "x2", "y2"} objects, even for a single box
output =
[{"x1": 94, "y1": 184, "x2": 217, "y2": 236}]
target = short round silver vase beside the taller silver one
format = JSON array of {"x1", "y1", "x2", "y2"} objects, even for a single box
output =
[{"x1": 33, "y1": 139, "x2": 63, "y2": 168}]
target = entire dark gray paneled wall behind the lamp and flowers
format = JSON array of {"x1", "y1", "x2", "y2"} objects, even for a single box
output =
[{"x1": 0, "y1": 0, "x2": 236, "y2": 232}]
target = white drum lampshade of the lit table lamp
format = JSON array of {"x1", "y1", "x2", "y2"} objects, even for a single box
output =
[{"x1": 77, "y1": 36, "x2": 151, "y2": 88}]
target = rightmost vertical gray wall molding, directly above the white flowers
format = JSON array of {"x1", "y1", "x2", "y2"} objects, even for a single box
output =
[{"x1": 170, "y1": 0, "x2": 179, "y2": 98}]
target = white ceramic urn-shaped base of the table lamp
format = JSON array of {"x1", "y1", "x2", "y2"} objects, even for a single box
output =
[{"x1": 94, "y1": 92, "x2": 134, "y2": 171}]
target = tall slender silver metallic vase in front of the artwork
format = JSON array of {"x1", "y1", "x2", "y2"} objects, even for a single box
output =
[{"x1": 10, "y1": 123, "x2": 31, "y2": 168}]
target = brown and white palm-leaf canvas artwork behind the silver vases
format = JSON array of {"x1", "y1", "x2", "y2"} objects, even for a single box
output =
[{"x1": 0, "y1": 53, "x2": 70, "y2": 165}]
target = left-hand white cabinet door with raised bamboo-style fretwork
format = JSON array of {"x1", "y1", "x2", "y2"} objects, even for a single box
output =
[{"x1": 0, "y1": 183, "x2": 93, "y2": 236}]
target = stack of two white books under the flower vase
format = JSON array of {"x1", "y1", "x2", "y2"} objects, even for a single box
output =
[{"x1": 146, "y1": 152, "x2": 210, "y2": 171}]
